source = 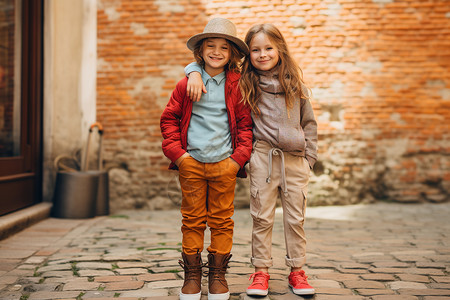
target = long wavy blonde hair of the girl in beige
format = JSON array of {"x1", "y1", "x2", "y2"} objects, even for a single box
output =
[{"x1": 240, "y1": 24, "x2": 308, "y2": 115}]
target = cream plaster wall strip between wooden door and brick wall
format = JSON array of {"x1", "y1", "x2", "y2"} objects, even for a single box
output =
[{"x1": 43, "y1": 0, "x2": 97, "y2": 201}]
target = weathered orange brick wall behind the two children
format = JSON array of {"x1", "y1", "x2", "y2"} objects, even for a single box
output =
[{"x1": 97, "y1": 0, "x2": 450, "y2": 209}]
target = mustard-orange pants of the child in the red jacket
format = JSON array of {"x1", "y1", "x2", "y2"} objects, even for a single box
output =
[{"x1": 179, "y1": 156, "x2": 239, "y2": 255}]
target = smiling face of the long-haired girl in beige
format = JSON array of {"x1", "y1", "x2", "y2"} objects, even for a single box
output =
[{"x1": 250, "y1": 32, "x2": 280, "y2": 71}]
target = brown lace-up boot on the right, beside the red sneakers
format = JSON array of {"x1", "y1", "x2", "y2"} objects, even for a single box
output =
[{"x1": 208, "y1": 253, "x2": 231, "y2": 300}]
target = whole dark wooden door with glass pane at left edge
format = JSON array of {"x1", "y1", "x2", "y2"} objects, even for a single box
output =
[{"x1": 0, "y1": 0, "x2": 43, "y2": 215}]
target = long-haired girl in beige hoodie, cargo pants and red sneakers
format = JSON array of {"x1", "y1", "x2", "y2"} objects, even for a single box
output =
[{"x1": 186, "y1": 24, "x2": 317, "y2": 295}]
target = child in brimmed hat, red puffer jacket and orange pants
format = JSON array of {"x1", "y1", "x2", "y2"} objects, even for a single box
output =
[{"x1": 161, "y1": 18, "x2": 252, "y2": 300}]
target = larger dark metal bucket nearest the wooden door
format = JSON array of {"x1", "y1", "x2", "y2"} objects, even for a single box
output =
[{"x1": 52, "y1": 172, "x2": 99, "y2": 219}]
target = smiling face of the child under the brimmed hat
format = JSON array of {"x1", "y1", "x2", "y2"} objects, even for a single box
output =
[{"x1": 202, "y1": 38, "x2": 230, "y2": 77}]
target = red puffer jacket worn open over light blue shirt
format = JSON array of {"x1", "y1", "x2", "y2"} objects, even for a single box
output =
[{"x1": 160, "y1": 72, "x2": 253, "y2": 178}]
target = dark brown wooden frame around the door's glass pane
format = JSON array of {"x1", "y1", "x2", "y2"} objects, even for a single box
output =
[{"x1": 0, "y1": 0, "x2": 44, "y2": 215}]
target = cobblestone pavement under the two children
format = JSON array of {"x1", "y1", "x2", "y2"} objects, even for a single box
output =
[{"x1": 0, "y1": 203, "x2": 450, "y2": 300}]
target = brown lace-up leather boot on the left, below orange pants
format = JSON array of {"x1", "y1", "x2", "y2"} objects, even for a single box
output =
[{"x1": 178, "y1": 253, "x2": 203, "y2": 300}]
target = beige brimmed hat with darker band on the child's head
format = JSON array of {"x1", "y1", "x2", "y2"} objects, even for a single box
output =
[{"x1": 187, "y1": 18, "x2": 249, "y2": 55}]
